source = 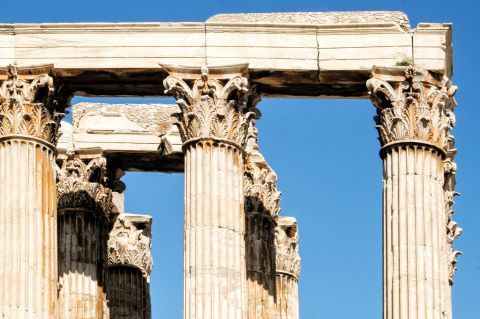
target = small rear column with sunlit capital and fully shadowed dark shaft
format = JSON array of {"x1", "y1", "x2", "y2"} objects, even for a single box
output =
[{"x1": 108, "y1": 213, "x2": 153, "y2": 319}]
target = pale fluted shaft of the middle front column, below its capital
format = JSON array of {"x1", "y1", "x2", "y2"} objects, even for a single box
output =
[{"x1": 184, "y1": 140, "x2": 246, "y2": 319}]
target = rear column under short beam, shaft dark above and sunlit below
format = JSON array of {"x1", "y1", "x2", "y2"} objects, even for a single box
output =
[{"x1": 57, "y1": 154, "x2": 112, "y2": 319}]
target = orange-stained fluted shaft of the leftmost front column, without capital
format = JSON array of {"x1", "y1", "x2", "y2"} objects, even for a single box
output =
[{"x1": 0, "y1": 136, "x2": 57, "y2": 319}]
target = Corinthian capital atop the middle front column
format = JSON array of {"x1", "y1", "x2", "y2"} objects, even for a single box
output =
[{"x1": 163, "y1": 65, "x2": 258, "y2": 147}]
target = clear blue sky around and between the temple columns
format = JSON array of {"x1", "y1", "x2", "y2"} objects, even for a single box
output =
[{"x1": 0, "y1": 0, "x2": 480, "y2": 319}]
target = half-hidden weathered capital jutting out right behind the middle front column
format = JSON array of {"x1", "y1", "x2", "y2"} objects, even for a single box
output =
[{"x1": 245, "y1": 126, "x2": 282, "y2": 218}]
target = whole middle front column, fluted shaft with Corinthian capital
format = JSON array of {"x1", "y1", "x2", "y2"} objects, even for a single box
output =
[{"x1": 164, "y1": 65, "x2": 255, "y2": 319}]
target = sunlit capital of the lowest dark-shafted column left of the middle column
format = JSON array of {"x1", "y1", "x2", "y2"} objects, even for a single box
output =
[{"x1": 108, "y1": 214, "x2": 153, "y2": 279}]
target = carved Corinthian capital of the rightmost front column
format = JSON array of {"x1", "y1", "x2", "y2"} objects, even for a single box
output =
[{"x1": 367, "y1": 67, "x2": 457, "y2": 153}]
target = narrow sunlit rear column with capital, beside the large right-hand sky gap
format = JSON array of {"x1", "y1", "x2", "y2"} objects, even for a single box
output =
[{"x1": 275, "y1": 216, "x2": 300, "y2": 319}]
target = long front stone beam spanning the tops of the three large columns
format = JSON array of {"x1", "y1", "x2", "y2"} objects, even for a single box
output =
[{"x1": 0, "y1": 12, "x2": 452, "y2": 98}]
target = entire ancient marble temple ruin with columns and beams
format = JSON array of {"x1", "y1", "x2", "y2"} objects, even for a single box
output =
[{"x1": 0, "y1": 12, "x2": 461, "y2": 319}]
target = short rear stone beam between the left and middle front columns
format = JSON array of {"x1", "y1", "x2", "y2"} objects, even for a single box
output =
[{"x1": 57, "y1": 103, "x2": 183, "y2": 172}]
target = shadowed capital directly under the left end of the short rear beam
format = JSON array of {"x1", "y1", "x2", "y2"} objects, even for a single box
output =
[{"x1": 57, "y1": 154, "x2": 112, "y2": 219}]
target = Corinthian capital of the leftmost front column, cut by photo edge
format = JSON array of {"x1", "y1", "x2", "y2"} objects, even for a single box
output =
[{"x1": 0, "y1": 65, "x2": 69, "y2": 145}]
